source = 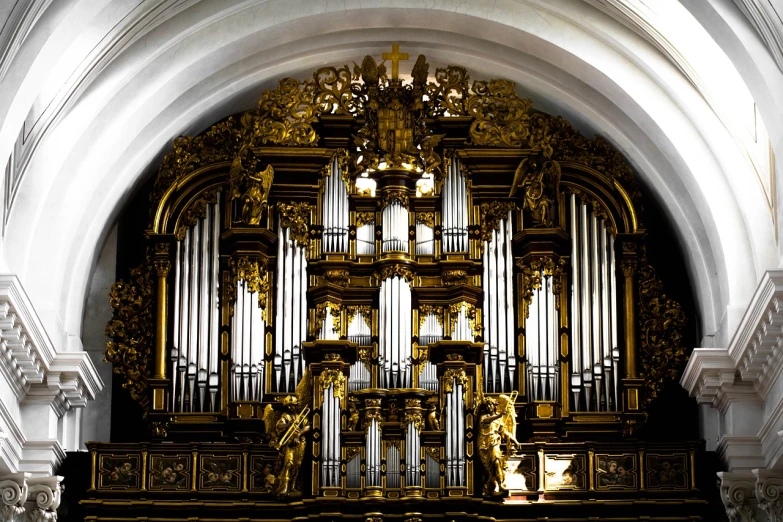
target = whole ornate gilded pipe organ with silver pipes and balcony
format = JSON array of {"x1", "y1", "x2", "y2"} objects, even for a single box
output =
[{"x1": 91, "y1": 46, "x2": 708, "y2": 518}]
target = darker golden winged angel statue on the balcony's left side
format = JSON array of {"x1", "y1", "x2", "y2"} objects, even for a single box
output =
[{"x1": 264, "y1": 368, "x2": 312, "y2": 497}]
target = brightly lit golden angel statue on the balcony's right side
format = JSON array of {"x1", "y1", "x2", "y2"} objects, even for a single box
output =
[{"x1": 477, "y1": 397, "x2": 519, "y2": 496}]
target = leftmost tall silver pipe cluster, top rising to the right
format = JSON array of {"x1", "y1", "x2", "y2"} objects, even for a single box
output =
[{"x1": 170, "y1": 198, "x2": 220, "y2": 412}]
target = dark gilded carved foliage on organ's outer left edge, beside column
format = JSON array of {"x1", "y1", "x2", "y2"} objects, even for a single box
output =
[{"x1": 104, "y1": 254, "x2": 155, "y2": 416}]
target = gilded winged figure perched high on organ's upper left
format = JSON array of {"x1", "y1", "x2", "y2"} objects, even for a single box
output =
[{"x1": 229, "y1": 147, "x2": 275, "y2": 225}]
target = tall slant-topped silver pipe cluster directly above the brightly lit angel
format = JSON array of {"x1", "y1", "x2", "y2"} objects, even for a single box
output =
[{"x1": 482, "y1": 212, "x2": 516, "y2": 393}]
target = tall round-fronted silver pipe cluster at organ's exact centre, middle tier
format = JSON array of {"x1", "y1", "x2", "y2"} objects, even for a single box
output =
[{"x1": 378, "y1": 276, "x2": 413, "y2": 388}]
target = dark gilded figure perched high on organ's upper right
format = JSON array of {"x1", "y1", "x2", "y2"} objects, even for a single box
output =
[{"x1": 511, "y1": 154, "x2": 560, "y2": 227}]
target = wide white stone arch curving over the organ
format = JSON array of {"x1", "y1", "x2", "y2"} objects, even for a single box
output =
[{"x1": 0, "y1": 0, "x2": 776, "y2": 362}]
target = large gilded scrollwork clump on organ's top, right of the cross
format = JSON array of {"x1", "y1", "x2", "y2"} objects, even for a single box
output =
[{"x1": 465, "y1": 80, "x2": 532, "y2": 147}]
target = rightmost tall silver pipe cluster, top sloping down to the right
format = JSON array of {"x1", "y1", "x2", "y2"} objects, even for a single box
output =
[{"x1": 569, "y1": 194, "x2": 620, "y2": 411}]
